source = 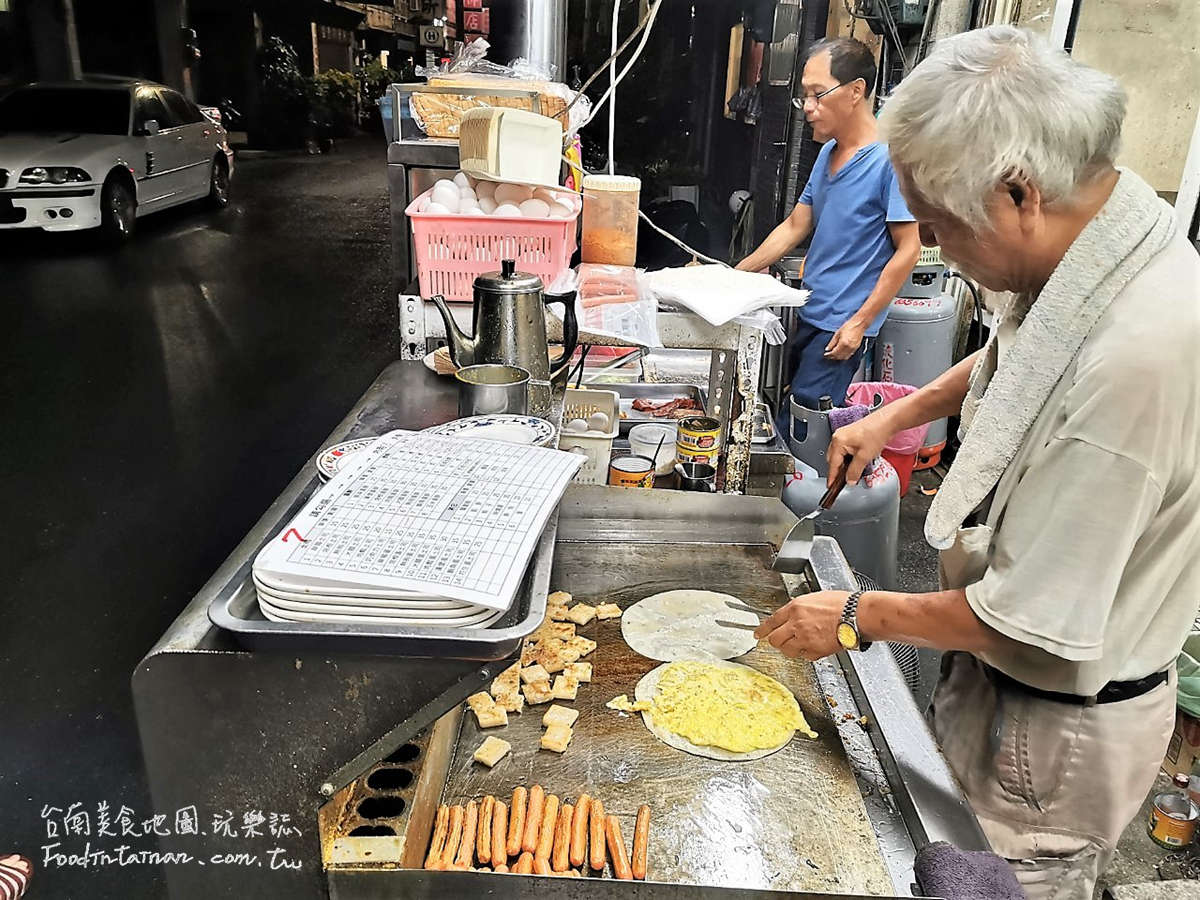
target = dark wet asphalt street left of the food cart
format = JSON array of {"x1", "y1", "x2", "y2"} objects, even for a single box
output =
[{"x1": 0, "y1": 136, "x2": 396, "y2": 900}]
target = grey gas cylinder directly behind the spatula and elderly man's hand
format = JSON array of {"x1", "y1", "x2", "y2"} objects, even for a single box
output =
[{"x1": 782, "y1": 400, "x2": 900, "y2": 589}]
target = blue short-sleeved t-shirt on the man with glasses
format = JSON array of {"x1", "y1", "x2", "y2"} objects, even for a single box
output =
[{"x1": 799, "y1": 140, "x2": 914, "y2": 337}]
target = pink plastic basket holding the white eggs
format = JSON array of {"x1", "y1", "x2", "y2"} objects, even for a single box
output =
[{"x1": 404, "y1": 188, "x2": 581, "y2": 300}]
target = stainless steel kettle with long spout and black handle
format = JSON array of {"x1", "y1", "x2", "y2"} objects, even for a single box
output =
[{"x1": 431, "y1": 259, "x2": 580, "y2": 382}]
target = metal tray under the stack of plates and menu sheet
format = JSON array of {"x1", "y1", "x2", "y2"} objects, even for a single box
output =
[{"x1": 209, "y1": 511, "x2": 558, "y2": 661}]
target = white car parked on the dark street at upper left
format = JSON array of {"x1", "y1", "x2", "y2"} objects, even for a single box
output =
[{"x1": 0, "y1": 80, "x2": 233, "y2": 241}]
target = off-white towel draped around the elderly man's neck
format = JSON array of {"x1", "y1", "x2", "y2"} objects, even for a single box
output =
[{"x1": 925, "y1": 169, "x2": 1175, "y2": 550}]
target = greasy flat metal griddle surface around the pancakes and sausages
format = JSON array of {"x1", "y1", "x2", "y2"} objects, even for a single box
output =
[{"x1": 442, "y1": 540, "x2": 892, "y2": 895}]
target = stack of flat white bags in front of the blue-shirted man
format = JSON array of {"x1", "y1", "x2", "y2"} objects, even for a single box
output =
[{"x1": 643, "y1": 265, "x2": 809, "y2": 326}]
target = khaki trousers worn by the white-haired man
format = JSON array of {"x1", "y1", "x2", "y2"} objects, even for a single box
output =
[{"x1": 930, "y1": 653, "x2": 1177, "y2": 900}]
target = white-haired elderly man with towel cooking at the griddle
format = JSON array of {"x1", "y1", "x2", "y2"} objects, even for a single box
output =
[{"x1": 758, "y1": 26, "x2": 1200, "y2": 900}]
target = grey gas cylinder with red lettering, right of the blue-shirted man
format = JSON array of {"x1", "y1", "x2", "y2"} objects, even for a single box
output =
[{"x1": 875, "y1": 294, "x2": 959, "y2": 469}]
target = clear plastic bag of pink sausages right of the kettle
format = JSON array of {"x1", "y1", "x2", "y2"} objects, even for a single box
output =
[{"x1": 547, "y1": 263, "x2": 662, "y2": 347}]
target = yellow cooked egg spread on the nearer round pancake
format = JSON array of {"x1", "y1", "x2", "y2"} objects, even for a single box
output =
[{"x1": 650, "y1": 662, "x2": 816, "y2": 752}]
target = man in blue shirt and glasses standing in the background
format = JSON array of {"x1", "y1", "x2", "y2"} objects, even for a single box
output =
[{"x1": 738, "y1": 37, "x2": 920, "y2": 424}]
